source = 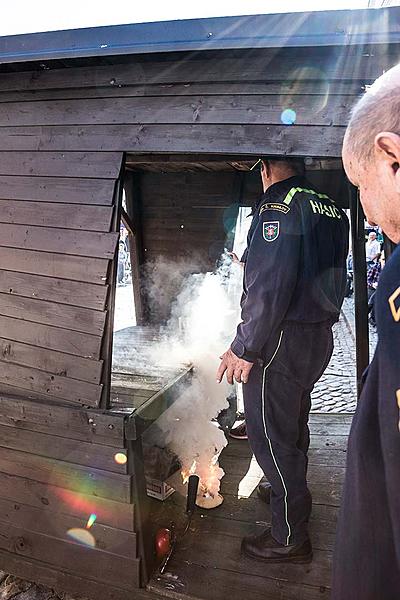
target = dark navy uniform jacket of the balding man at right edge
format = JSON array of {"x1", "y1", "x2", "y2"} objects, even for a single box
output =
[{"x1": 332, "y1": 241, "x2": 400, "y2": 600}]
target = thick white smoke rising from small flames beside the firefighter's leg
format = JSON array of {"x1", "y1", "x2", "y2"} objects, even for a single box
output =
[{"x1": 146, "y1": 255, "x2": 242, "y2": 495}]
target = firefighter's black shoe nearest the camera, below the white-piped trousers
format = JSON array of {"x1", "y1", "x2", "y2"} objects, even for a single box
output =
[{"x1": 242, "y1": 528, "x2": 312, "y2": 564}]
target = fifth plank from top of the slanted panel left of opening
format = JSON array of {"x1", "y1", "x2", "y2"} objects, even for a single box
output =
[{"x1": 0, "y1": 247, "x2": 109, "y2": 286}]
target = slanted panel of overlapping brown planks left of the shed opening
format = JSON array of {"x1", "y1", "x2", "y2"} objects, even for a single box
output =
[{"x1": 0, "y1": 155, "x2": 122, "y2": 406}]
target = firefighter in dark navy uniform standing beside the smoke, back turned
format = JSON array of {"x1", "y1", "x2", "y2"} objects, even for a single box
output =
[{"x1": 217, "y1": 159, "x2": 348, "y2": 562}]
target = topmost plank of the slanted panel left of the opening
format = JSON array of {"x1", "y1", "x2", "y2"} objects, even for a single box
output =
[{"x1": 0, "y1": 151, "x2": 122, "y2": 179}]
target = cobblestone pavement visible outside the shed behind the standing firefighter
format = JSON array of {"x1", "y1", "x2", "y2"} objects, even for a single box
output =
[{"x1": 311, "y1": 298, "x2": 377, "y2": 412}]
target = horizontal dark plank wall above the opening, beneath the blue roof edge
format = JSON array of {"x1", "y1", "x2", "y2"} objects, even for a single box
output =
[{"x1": 0, "y1": 45, "x2": 399, "y2": 157}]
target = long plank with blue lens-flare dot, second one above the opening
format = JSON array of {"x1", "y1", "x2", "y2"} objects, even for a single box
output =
[{"x1": 0, "y1": 95, "x2": 356, "y2": 127}]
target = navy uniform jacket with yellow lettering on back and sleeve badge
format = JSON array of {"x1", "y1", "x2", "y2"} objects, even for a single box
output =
[{"x1": 231, "y1": 177, "x2": 348, "y2": 361}]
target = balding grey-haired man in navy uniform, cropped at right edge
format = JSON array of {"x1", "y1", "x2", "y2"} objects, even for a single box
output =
[{"x1": 332, "y1": 66, "x2": 400, "y2": 600}]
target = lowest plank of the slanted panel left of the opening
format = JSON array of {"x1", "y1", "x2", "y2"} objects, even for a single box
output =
[{"x1": 0, "y1": 360, "x2": 102, "y2": 408}]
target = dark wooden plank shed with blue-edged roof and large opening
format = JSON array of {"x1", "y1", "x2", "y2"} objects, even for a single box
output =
[{"x1": 0, "y1": 8, "x2": 400, "y2": 599}]
